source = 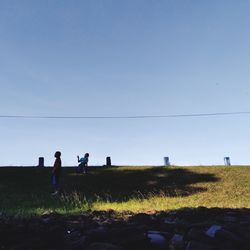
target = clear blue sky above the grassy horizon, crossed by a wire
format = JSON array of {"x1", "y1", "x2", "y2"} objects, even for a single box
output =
[{"x1": 0, "y1": 0, "x2": 250, "y2": 165}]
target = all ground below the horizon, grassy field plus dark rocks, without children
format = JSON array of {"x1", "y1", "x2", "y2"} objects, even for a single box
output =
[{"x1": 0, "y1": 167, "x2": 250, "y2": 250}]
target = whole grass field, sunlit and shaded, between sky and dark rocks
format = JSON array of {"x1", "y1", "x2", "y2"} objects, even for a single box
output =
[{"x1": 0, "y1": 166, "x2": 250, "y2": 216}]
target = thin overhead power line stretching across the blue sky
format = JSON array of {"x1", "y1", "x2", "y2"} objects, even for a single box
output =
[{"x1": 0, "y1": 111, "x2": 250, "y2": 119}]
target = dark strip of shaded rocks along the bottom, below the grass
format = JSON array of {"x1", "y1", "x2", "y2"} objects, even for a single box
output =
[{"x1": 0, "y1": 208, "x2": 250, "y2": 250}]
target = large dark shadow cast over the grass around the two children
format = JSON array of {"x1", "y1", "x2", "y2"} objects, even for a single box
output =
[{"x1": 0, "y1": 167, "x2": 219, "y2": 215}]
